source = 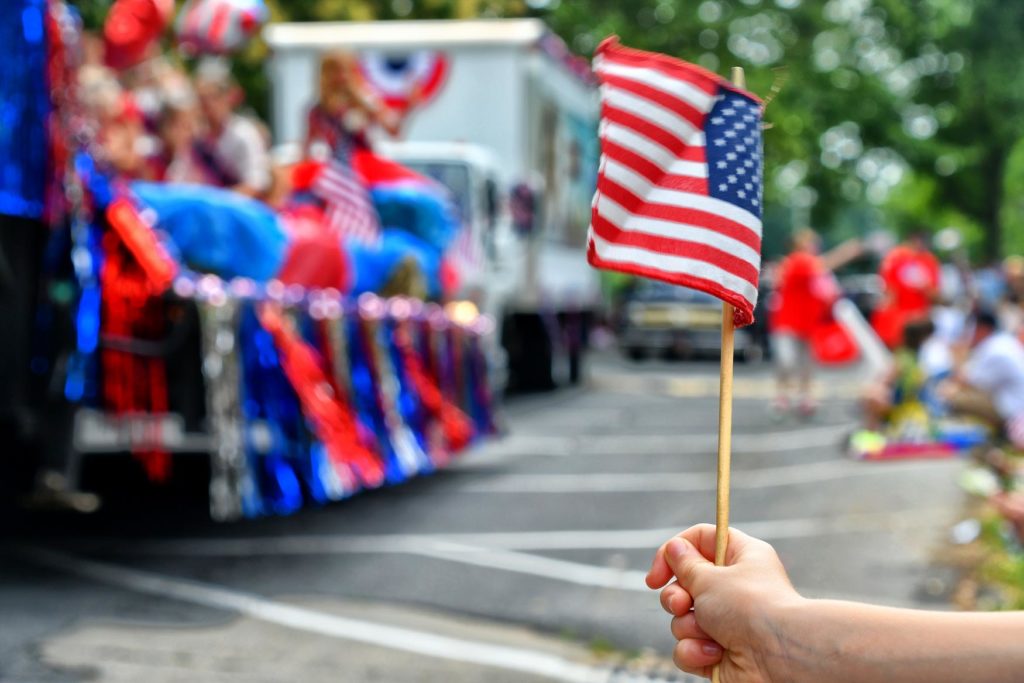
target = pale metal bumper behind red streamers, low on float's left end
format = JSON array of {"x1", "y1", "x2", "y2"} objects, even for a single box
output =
[{"x1": 74, "y1": 410, "x2": 210, "y2": 453}]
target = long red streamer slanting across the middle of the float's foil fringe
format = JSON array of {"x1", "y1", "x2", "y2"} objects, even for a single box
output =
[{"x1": 258, "y1": 305, "x2": 384, "y2": 487}]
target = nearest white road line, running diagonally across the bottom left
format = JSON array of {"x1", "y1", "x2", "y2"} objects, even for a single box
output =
[{"x1": 24, "y1": 548, "x2": 610, "y2": 683}]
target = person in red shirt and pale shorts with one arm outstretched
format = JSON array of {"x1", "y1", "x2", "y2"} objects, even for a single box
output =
[{"x1": 768, "y1": 228, "x2": 863, "y2": 417}]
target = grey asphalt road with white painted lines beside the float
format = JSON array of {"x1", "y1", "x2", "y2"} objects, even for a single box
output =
[{"x1": 0, "y1": 356, "x2": 963, "y2": 683}]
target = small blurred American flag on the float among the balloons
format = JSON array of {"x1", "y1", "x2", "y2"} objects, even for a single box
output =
[{"x1": 312, "y1": 145, "x2": 380, "y2": 244}]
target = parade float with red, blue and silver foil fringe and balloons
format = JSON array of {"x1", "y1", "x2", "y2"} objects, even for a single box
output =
[{"x1": 0, "y1": 0, "x2": 495, "y2": 520}]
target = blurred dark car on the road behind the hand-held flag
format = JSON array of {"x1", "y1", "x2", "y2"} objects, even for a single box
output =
[{"x1": 618, "y1": 280, "x2": 763, "y2": 361}]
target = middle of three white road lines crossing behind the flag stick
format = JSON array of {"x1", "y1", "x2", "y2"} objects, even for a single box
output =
[{"x1": 456, "y1": 460, "x2": 950, "y2": 494}]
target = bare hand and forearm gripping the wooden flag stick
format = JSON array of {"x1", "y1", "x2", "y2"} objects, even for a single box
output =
[{"x1": 647, "y1": 524, "x2": 1024, "y2": 683}]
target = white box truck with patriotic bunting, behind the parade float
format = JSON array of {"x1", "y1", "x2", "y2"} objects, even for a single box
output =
[{"x1": 264, "y1": 19, "x2": 600, "y2": 389}]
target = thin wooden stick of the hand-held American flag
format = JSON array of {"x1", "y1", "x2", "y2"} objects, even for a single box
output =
[{"x1": 711, "y1": 67, "x2": 746, "y2": 683}]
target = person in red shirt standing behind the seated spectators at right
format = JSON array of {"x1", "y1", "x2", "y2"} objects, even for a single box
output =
[{"x1": 871, "y1": 230, "x2": 941, "y2": 348}]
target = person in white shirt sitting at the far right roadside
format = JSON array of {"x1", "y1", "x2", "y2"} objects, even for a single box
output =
[{"x1": 942, "y1": 310, "x2": 1024, "y2": 449}]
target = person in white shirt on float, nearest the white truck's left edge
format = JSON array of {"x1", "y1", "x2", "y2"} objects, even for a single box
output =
[{"x1": 196, "y1": 59, "x2": 272, "y2": 198}]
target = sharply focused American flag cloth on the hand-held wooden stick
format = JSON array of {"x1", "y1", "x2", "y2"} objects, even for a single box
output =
[{"x1": 587, "y1": 38, "x2": 763, "y2": 327}]
